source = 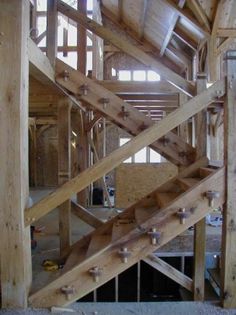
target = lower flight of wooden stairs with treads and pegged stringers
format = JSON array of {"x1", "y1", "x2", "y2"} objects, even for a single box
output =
[{"x1": 29, "y1": 159, "x2": 224, "y2": 307}]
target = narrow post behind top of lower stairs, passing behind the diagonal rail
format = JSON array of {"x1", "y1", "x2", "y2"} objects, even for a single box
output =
[{"x1": 193, "y1": 73, "x2": 207, "y2": 301}]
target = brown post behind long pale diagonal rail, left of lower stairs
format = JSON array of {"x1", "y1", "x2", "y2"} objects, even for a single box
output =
[{"x1": 58, "y1": 98, "x2": 71, "y2": 255}]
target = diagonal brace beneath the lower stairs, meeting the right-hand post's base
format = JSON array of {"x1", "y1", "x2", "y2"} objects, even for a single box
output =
[{"x1": 143, "y1": 254, "x2": 193, "y2": 292}]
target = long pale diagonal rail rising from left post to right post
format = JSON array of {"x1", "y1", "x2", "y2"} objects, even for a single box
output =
[{"x1": 25, "y1": 80, "x2": 225, "y2": 226}]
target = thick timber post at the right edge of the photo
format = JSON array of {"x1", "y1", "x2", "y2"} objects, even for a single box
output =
[{"x1": 221, "y1": 51, "x2": 236, "y2": 308}]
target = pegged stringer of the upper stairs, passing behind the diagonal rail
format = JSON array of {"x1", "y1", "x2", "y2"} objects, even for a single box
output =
[{"x1": 56, "y1": 60, "x2": 194, "y2": 165}]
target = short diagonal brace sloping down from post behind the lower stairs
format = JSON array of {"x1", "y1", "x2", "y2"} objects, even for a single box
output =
[{"x1": 71, "y1": 201, "x2": 103, "y2": 229}]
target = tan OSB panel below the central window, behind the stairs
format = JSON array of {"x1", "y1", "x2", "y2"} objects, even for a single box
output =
[{"x1": 115, "y1": 163, "x2": 178, "y2": 208}]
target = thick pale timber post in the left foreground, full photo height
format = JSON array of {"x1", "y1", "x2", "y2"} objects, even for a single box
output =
[{"x1": 0, "y1": 0, "x2": 32, "y2": 308}]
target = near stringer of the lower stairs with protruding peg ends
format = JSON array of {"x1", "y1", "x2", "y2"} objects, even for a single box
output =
[{"x1": 29, "y1": 168, "x2": 224, "y2": 307}]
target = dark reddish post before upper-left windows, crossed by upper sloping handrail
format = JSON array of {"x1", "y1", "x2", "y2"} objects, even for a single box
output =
[{"x1": 77, "y1": 0, "x2": 87, "y2": 74}]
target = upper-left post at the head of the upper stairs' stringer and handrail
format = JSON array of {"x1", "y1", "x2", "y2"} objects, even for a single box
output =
[{"x1": 46, "y1": 0, "x2": 57, "y2": 68}]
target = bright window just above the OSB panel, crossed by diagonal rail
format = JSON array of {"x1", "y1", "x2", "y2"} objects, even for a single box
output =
[{"x1": 120, "y1": 137, "x2": 163, "y2": 163}]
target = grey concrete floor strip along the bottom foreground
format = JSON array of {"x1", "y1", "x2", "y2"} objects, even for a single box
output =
[{"x1": 0, "y1": 302, "x2": 236, "y2": 315}]
